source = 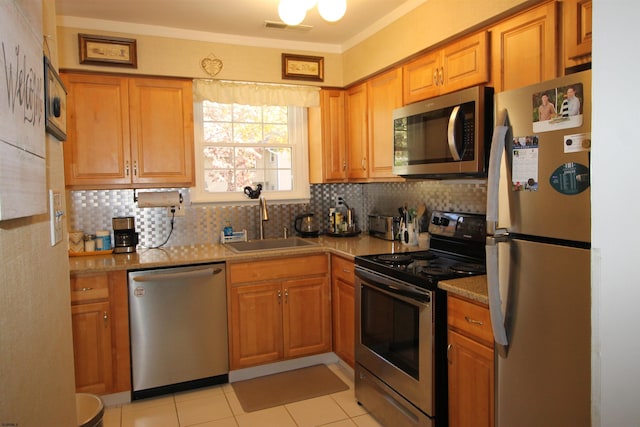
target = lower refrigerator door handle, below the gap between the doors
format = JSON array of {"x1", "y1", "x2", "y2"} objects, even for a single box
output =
[{"x1": 486, "y1": 235, "x2": 509, "y2": 354}]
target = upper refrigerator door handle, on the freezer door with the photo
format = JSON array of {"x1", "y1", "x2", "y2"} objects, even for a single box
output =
[{"x1": 487, "y1": 111, "x2": 509, "y2": 235}]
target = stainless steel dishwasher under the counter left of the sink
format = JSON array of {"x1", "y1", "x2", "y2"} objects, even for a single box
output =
[{"x1": 129, "y1": 263, "x2": 229, "y2": 400}]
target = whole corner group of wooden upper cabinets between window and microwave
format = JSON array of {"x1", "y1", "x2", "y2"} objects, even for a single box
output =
[{"x1": 309, "y1": 73, "x2": 402, "y2": 183}]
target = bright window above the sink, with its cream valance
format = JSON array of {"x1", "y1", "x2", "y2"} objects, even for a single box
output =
[{"x1": 191, "y1": 80, "x2": 319, "y2": 203}]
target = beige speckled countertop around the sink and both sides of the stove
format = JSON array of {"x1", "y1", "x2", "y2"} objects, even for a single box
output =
[{"x1": 69, "y1": 234, "x2": 488, "y2": 304}]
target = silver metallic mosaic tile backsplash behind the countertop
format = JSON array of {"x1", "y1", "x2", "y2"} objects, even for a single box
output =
[{"x1": 67, "y1": 180, "x2": 486, "y2": 247}]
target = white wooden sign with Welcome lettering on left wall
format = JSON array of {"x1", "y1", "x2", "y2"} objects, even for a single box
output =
[{"x1": 0, "y1": 0, "x2": 47, "y2": 221}]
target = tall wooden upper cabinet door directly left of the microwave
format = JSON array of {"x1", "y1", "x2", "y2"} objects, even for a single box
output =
[{"x1": 367, "y1": 67, "x2": 402, "y2": 181}]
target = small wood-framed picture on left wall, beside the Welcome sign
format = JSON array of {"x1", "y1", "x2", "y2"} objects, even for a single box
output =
[{"x1": 44, "y1": 56, "x2": 67, "y2": 141}]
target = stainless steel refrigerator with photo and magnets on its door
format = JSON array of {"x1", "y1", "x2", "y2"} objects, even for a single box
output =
[{"x1": 487, "y1": 71, "x2": 591, "y2": 427}]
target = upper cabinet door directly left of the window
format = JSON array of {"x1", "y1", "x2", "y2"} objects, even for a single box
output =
[{"x1": 129, "y1": 78, "x2": 194, "y2": 185}]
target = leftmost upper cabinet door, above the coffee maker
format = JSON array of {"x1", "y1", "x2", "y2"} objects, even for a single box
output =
[{"x1": 61, "y1": 73, "x2": 131, "y2": 186}]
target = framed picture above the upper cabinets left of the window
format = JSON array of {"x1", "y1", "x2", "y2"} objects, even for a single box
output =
[{"x1": 78, "y1": 34, "x2": 138, "y2": 68}]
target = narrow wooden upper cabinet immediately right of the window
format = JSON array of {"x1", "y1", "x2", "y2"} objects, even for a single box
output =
[{"x1": 308, "y1": 89, "x2": 347, "y2": 184}]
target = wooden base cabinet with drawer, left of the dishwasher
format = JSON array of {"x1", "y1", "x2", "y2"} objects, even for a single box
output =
[{"x1": 70, "y1": 270, "x2": 131, "y2": 394}]
